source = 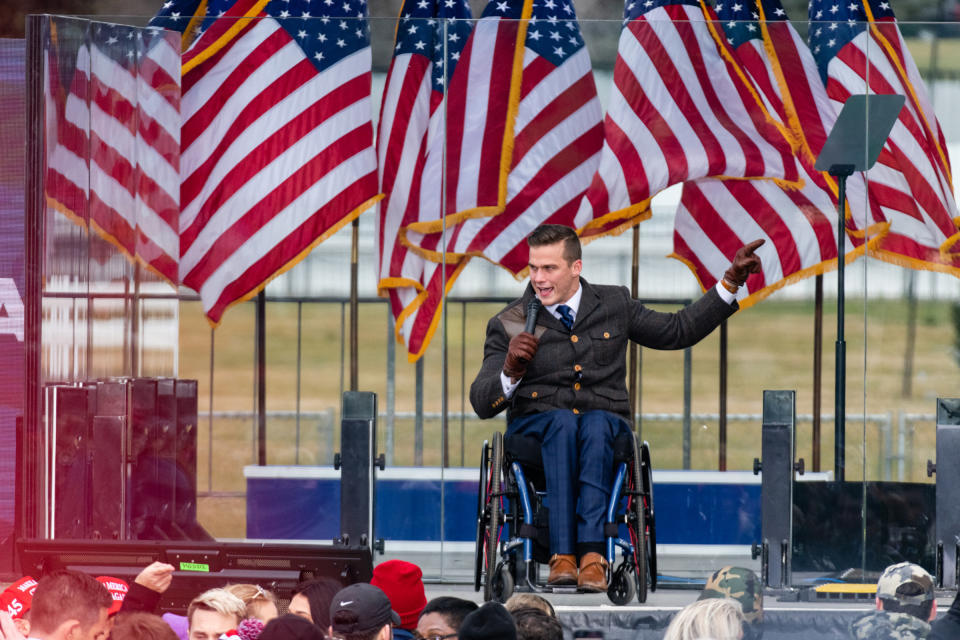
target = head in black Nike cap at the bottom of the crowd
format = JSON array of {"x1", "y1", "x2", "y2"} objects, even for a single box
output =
[{"x1": 327, "y1": 582, "x2": 400, "y2": 640}]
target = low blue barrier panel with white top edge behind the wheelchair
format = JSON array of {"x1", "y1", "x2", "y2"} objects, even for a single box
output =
[{"x1": 244, "y1": 466, "x2": 772, "y2": 545}]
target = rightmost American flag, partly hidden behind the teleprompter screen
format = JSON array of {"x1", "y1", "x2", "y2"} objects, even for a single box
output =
[{"x1": 809, "y1": 0, "x2": 960, "y2": 275}]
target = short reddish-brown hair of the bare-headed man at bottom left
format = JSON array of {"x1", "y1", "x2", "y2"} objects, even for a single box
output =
[{"x1": 30, "y1": 570, "x2": 113, "y2": 634}]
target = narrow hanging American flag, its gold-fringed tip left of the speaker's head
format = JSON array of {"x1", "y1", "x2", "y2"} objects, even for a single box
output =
[{"x1": 377, "y1": 0, "x2": 472, "y2": 361}]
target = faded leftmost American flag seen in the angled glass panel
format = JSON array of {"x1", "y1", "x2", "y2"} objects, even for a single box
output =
[{"x1": 47, "y1": 24, "x2": 180, "y2": 284}]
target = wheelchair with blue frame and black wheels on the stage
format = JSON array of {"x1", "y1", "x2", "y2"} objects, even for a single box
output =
[{"x1": 474, "y1": 432, "x2": 657, "y2": 605}]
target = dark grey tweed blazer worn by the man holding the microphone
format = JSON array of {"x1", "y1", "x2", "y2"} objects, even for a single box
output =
[{"x1": 470, "y1": 278, "x2": 738, "y2": 422}]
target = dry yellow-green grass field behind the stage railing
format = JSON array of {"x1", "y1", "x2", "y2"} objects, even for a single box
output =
[{"x1": 180, "y1": 292, "x2": 960, "y2": 537}]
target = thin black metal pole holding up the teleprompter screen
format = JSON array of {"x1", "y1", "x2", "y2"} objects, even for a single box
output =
[{"x1": 830, "y1": 170, "x2": 853, "y2": 482}]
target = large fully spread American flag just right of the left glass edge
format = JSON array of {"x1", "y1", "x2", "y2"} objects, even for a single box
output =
[{"x1": 155, "y1": 0, "x2": 378, "y2": 325}]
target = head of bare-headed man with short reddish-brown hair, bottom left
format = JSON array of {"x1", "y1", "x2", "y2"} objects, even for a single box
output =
[{"x1": 30, "y1": 571, "x2": 113, "y2": 640}]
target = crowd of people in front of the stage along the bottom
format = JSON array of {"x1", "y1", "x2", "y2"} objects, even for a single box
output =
[{"x1": 0, "y1": 560, "x2": 960, "y2": 640}]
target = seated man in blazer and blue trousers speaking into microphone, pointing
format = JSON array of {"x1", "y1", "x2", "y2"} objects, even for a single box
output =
[{"x1": 470, "y1": 224, "x2": 763, "y2": 592}]
